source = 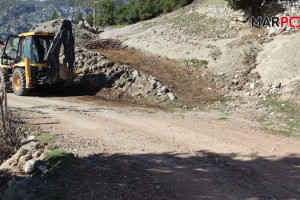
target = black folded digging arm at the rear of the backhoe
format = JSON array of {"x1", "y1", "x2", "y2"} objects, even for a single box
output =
[{"x1": 45, "y1": 20, "x2": 75, "y2": 82}]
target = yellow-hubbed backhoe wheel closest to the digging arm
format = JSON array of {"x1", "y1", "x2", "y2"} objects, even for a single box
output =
[{"x1": 12, "y1": 68, "x2": 27, "y2": 96}]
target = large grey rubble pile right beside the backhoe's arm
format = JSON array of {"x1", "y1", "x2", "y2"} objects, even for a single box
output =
[{"x1": 75, "y1": 48, "x2": 176, "y2": 103}]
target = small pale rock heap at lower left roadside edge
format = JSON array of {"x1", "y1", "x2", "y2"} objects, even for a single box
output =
[{"x1": 0, "y1": 136, "x2": 47, "y2": 174}]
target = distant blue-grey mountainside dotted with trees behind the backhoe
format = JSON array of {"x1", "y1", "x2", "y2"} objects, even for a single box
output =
[{"x1": 0, "y1": 0, "x2": 89, "y2": 40}]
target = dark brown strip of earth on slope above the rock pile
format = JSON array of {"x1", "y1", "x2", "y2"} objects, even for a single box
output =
[{"x1": 98, "y1": 49, "x2": 218, "y2": 107}]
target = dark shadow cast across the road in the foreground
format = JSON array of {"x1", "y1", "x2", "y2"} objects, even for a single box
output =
[{"x1": 4, "y1": 151, "x2": 300, "y2": 200}]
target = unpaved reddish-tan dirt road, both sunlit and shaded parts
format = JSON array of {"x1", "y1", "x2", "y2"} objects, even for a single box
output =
[{"x1": 8, "y1": 95, "x2": 300, "y2": 199}]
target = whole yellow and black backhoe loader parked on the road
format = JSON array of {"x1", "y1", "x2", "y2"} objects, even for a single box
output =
[{"x1": 0, "y1": 20, "x2": 75, "y2": 96}]
